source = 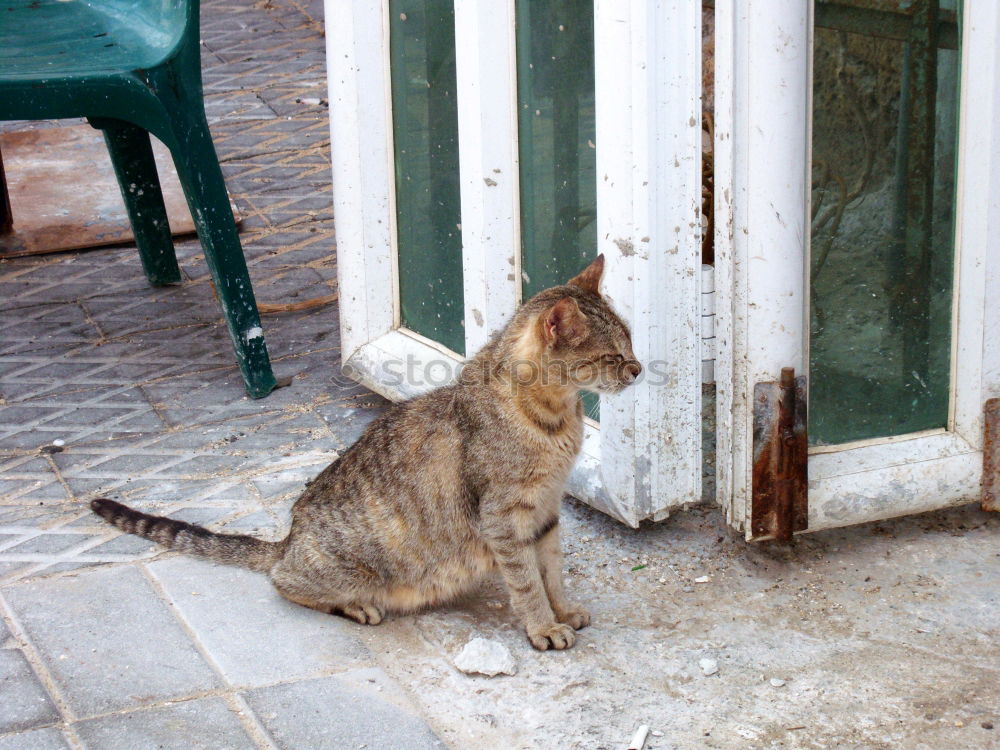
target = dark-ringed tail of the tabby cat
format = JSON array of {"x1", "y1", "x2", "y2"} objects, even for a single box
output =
[{"x1": 90, "y1": 498, "x2": 284, "y2": 573}]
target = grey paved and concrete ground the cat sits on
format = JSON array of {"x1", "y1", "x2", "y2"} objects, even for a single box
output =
[{"x1": 0, "y1": 0, "x2": 1000, "y2": 750}]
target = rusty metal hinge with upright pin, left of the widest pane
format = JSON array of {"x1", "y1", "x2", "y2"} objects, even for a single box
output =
[{"x1": 750, "y1": 367, "x2": 809, "y2": 541}]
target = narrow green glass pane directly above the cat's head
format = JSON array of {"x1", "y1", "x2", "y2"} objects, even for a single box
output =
[{"x1": 517, "y1": 0, "x2": 598, "y2": 419}]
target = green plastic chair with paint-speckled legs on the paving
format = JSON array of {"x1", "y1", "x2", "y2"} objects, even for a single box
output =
[{"x1": 0, "y1": 0, "x2": 275, "y2": 398}]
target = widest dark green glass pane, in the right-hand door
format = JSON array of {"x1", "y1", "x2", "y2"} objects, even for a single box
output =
[{"x1": 809, "y1": 0, "x2": 961, "y2": 445}]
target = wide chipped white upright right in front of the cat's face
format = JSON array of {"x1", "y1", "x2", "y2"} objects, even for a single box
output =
[{"x1": 594, "y1": 0, "x2": 702, "y2": 525}]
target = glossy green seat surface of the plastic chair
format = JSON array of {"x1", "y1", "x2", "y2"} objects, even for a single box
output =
[{"x1": 0, "y1": 0, "x2": 176, "y2": 83}]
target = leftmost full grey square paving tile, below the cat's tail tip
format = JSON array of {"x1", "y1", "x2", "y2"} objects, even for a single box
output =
[{"x1": 3, "y1": 566, "x2": 220, "y2": 717}]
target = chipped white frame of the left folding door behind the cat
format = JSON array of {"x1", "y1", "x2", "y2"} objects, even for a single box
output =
[{"x1": 325, "y1": 0, "x2": 702, "y2": 526}]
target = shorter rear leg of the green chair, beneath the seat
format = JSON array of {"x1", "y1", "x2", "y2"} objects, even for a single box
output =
[{"x1": 92, "y1": 120, "x2": 181, "y2": 286}]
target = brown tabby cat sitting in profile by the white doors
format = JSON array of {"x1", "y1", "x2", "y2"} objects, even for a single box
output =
[{"x1": 91, "y1": 256, "x2": 641, "y2": 650}]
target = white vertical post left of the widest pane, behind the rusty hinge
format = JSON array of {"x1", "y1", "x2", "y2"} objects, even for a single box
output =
[{"x1": 715, "y1": 0, "x2": 811, "y2": 535}]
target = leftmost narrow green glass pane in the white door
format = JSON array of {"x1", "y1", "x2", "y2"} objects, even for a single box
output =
[{"x1": 392, "y1": 0, "x2": 465, "y2": 353}]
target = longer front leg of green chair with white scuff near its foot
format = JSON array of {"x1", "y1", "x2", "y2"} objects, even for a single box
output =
[{"x1": 167, "y1": 115, "x2": 276, "y2": 398}]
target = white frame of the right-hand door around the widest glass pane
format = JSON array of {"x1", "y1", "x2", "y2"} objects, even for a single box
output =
[{"x1": 715, "y1": 0, "x2": 1000, "y2": 538}]
